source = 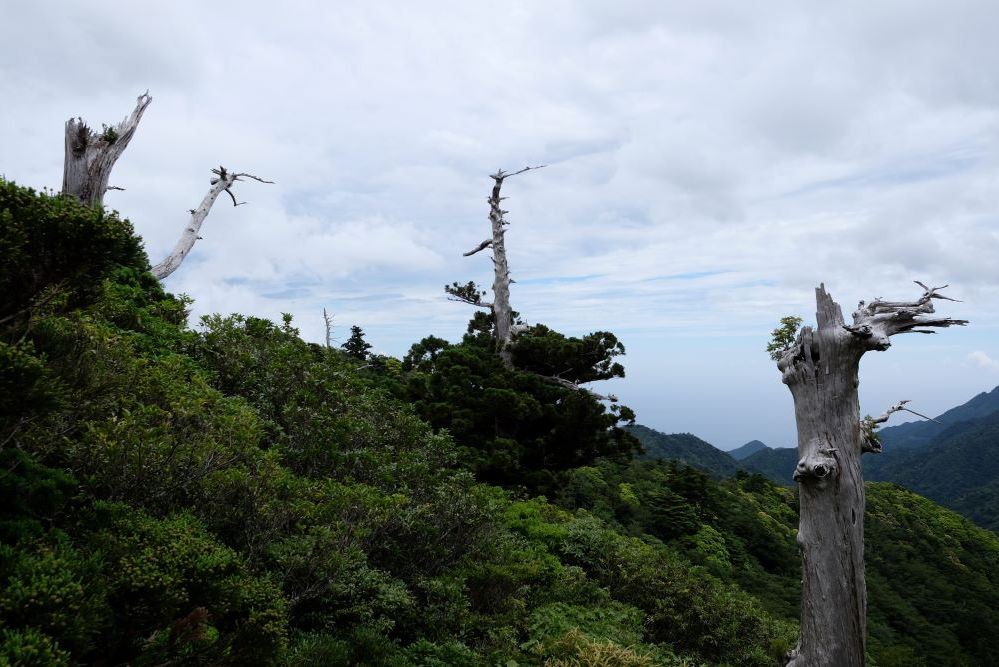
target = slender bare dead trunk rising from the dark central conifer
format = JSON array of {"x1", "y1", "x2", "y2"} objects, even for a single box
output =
[{"x1": 454, "y1": 165, "x2": 544, "y2": 368}]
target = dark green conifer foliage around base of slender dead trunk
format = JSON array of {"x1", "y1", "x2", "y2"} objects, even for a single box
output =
[{"x1": 395, "y1": 314, "x2": 638, "y2": 492}]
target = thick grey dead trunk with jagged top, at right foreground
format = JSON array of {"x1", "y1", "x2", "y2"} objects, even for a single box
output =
[{"x1": 777, "y1": 281, "x2": 967, "y2": 667}]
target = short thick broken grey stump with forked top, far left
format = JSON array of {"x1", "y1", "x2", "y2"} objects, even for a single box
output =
[{"x1": 62, "y1": 90, "x2": 153, "y2": 206}]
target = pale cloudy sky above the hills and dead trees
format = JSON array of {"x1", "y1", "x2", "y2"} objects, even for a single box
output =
[{"x1": 0, "y1": 0, "x2": 999, "y2": 449}]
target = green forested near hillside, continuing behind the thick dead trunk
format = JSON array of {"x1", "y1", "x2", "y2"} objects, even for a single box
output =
[{"x1": 0, "y1": 182, "x2": 999, "y2": 667}]
